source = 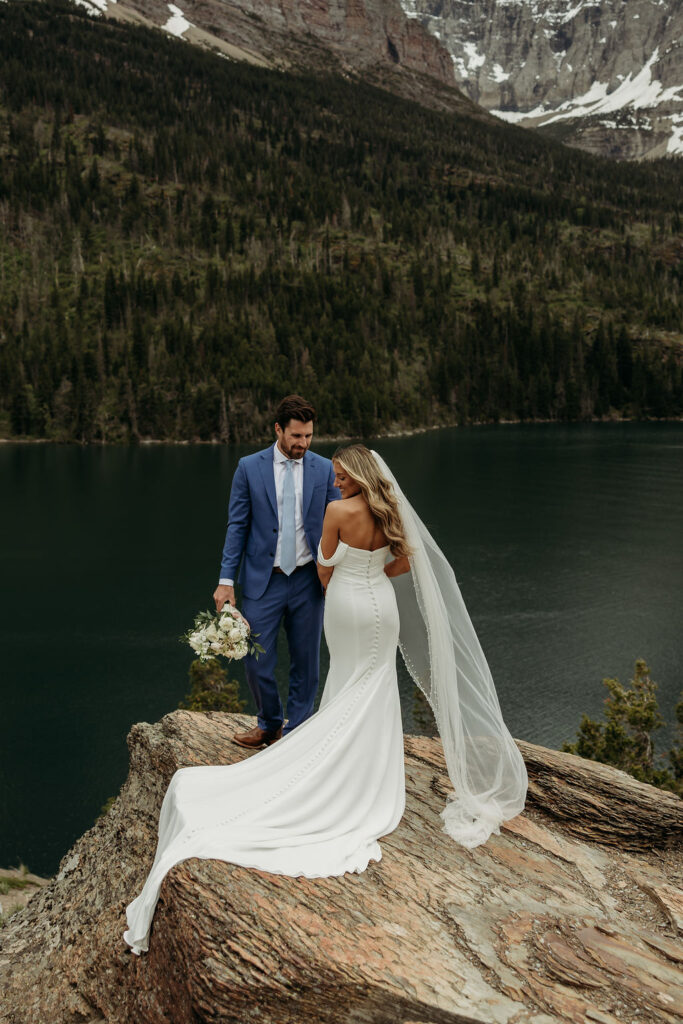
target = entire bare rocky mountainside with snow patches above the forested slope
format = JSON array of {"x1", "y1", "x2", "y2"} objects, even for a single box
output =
[{"x1": 77, "y1": 0, "x2": 683, "y2": 159}]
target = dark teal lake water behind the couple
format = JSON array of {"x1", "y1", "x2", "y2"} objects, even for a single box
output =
[{"x1": 0, "y1": 423, "x2": 683, "y2": 873}]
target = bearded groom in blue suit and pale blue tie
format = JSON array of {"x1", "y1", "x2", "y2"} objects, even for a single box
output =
[{"x1": 213, "y1": 394, "x2": 340, "y2": 750}]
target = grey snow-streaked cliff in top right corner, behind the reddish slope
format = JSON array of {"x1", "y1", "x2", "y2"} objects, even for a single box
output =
[{"x1": 401, "y1": 0, "x2": 683, "y2": 159}]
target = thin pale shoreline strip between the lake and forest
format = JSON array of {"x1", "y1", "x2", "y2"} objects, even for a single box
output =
[{"x1": 0, "y1": 416, "x2": 683, "y2": 447}]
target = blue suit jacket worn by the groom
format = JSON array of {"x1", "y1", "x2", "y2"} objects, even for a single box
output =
[{"x1": 220, "y1": 445, "x2": 341, "y2": 600}]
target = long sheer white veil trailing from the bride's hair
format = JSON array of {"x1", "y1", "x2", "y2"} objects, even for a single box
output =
[{"x1": 373, "y1": 452, "x2": 527, "y2": 848}]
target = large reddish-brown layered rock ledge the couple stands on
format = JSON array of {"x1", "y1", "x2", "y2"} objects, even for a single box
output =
[{"x1": 0, "y1": 712, "x2": 683, "y2": 1024}]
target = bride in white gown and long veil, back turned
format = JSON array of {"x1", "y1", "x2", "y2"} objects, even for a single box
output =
[{"x1": 124, "y1": 444, "x2": 526, "y2": 953}]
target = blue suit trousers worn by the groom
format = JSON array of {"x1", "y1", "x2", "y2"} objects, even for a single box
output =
[{"x1": 242, "y1": 562, "x2": 325, "y2": 732}]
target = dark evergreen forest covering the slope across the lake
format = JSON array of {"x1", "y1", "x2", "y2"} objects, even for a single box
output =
[{"x1": 0, "y1": 0, "x2": 683, "y2": 442}]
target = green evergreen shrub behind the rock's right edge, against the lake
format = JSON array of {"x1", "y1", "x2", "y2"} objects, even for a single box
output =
[{"x1": 561, "y1": 658, "x2": 683, "y2": 796}]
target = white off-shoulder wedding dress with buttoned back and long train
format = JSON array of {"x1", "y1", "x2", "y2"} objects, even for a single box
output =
[{"x1": 124, "y1": 541, "x2": 405, "y2": 953}]
